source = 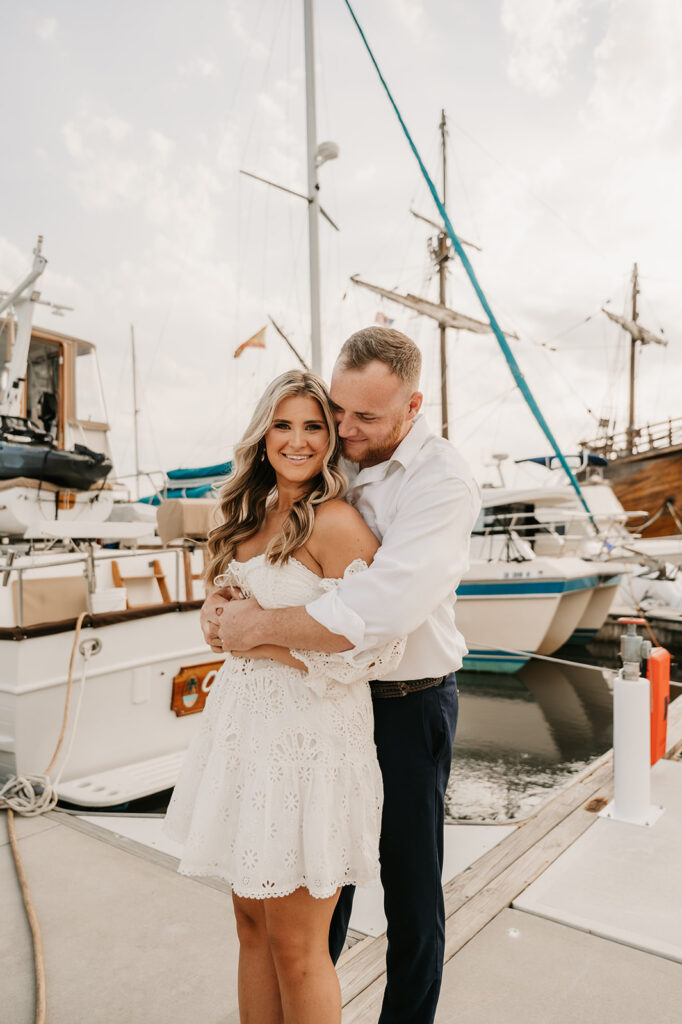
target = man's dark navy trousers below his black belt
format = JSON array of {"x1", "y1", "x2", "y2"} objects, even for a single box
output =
[{"x1": 330, "y1": 674, "x2": 458, "y2": 1024}]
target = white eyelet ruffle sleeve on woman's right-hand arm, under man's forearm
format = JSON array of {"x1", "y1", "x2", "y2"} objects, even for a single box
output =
[{"x1": 291, "y1": 558, "x2": 407, "y2": 693}]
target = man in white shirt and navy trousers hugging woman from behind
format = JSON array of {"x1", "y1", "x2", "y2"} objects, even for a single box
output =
[{"x1": 202, "y1": 327, "x2": 480, "y2": 1024}]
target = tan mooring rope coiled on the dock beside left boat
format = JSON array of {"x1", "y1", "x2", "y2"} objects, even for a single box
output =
[{"x1": 0, "y1": 611, "x2": 90, "y2": 1024}]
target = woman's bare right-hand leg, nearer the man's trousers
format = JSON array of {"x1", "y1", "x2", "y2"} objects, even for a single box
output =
[{"x1": 264, "y1": 889, "x2": 341, "y2": 1024}]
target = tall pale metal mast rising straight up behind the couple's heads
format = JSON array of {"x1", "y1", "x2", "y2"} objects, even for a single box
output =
[{"x1": 303, "y1": 0, "x2": 322, "y2": 374}]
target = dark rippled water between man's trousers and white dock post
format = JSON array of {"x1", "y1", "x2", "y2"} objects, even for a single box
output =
[{"x1": 445, "y1": 662, "x2": 612, "y2": 821}]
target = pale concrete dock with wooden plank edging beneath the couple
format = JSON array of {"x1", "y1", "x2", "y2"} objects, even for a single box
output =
[{"x1": 5, "y1": 701, "x2": 682, "y2": 1024}]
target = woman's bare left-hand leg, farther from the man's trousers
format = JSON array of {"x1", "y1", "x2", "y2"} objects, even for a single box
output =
[{"x1": 232, "y1": 893, "x2": 284, "y2": 1024}]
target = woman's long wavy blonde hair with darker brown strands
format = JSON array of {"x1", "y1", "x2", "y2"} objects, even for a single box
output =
[{"x1": 205, "y1": 370, "x2": 347, "y2": 584}]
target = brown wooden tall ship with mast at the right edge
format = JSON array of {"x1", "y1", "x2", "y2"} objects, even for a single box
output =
[{"x1": 581, "y1": 263, "x2": 682, "y2": 537}]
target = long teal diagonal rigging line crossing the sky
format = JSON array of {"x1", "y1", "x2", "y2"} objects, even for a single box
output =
[{"x1": 344, "y1": 0, "x2": 599, "y2": 532}]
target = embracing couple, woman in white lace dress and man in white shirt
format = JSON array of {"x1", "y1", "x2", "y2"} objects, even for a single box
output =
[{"x1": 166, "y1": 327, "x2": 479, "y2": 1024}]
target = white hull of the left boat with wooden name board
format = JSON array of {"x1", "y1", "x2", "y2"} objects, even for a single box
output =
[{"x1": 0, "y1": 609, "x2": 216, "y2": 806}]
